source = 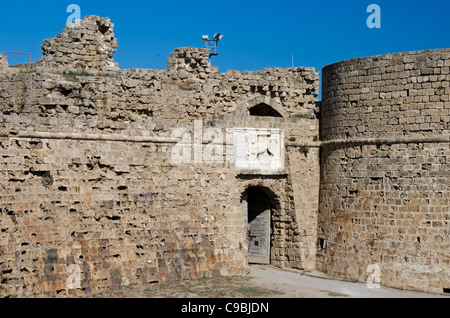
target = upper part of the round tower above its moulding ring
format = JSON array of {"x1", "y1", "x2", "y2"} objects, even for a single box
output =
[{"x1": 322, "y1": 49, "x2": 450, "y2": 140}]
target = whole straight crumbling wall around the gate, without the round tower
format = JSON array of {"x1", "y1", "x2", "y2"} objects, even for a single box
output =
[{"x1": 0, "y1": 18, "x2": 319, "y2": 297}]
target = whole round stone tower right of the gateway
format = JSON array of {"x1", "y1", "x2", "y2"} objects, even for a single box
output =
[{"x1": 318, "y1": 49, "x2": 450, "y2": 293}]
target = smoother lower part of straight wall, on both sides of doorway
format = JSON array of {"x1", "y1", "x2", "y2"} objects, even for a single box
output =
[{"x1": 0, "y1": 112, "x2": 319, "y2": 297}]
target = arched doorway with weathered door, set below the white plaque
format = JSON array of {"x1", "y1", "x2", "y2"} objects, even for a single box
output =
[{"x1": 242, "y1": 187, "x2": 272, "y2": 265}]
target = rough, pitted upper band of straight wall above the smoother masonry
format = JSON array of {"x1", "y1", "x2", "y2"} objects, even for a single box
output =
[{"x1": 0, "y1": 61, "x2": 319, "y2": 126}]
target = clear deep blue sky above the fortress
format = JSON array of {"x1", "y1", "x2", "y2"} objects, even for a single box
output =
[{"x1": 0, "y1": 0, "x2": 450, "y2": 72}]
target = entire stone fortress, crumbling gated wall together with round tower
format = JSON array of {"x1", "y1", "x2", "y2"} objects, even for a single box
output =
[{"x1": 0, "y1": 16, "x2": 450, "y2": 297}]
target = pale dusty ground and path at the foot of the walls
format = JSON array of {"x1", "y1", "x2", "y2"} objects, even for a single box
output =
[{"x1": 94, "y1": 266, "x2": 450, "y2": 299}]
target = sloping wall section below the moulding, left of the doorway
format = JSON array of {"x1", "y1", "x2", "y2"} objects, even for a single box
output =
[{"x1": 0, "y1": 133, "x2": 247, "y2": 297}]
